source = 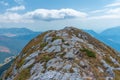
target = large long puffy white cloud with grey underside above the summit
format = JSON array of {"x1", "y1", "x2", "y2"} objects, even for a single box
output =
[{"x1": 24, "y1": 9, "x2": 87, "y2": 21}]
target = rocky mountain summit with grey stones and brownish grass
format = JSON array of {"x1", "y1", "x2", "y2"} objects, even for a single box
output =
[{"x1": 2, "y1": 27, "x2": 120, "y2": 80}]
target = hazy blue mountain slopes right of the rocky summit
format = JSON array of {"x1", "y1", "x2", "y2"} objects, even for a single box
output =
[{"x1": 84, "y1": 27, "x2": 120, "y2": 51}]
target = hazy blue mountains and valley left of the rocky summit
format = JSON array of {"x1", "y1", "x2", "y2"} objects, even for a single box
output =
[{"x1": 0, "y1": 28, "x2": 41, "y2": 63}]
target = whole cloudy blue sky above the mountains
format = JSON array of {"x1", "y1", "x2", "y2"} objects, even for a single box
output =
[{"x1": 0, "y1": 0, "x2": 120, "y2": 32}]
